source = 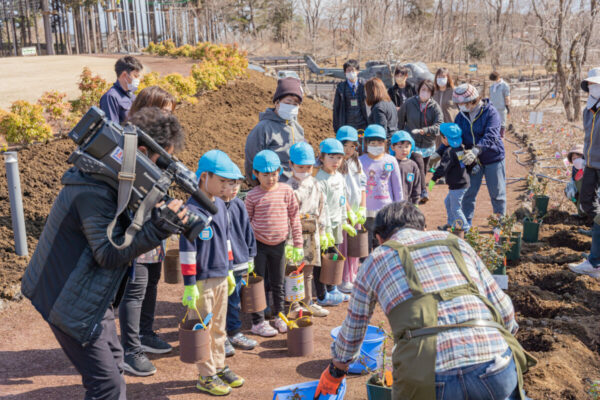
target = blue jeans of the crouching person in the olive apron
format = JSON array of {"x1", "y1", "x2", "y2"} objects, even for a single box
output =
[{"x1": 435, "y1": 349, "x2": 519, "y2": 400}]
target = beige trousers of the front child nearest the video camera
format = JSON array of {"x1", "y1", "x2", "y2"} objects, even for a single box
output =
[{"x1": 196, "y1": 278, "x2": 227, "y2": 377}]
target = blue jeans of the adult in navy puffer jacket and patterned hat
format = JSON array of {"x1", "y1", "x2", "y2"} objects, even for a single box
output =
[{"x1": 463, "y1": 160, "x2": 506, "y2": 225}]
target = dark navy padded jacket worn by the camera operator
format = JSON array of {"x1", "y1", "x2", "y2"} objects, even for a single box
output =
[{"x1": 21, "y1": 167, "x2": 170, "y2": 346}]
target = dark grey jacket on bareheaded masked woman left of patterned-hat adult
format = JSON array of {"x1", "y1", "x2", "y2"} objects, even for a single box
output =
[{"x1": 398, "y1": 96, "x2": 444, "y2": 149}]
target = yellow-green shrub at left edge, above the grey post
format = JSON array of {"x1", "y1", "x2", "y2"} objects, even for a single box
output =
[{"x1": 0, "y1": 100, "x2": 52, "y2": 144}]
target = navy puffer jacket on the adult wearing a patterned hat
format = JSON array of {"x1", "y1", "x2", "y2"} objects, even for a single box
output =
[{"x1": 458, "y1": 99, "x2": 504, "y2": 165}]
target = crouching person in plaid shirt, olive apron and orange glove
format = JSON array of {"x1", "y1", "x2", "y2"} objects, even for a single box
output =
[{"x1": 317, "y1": 202, "x2": 535, "y2": 400}]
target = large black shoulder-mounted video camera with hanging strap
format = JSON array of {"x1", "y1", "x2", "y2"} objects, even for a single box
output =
[{"x1": 68, "y1": 107, "x2": 217, "y2": 249}]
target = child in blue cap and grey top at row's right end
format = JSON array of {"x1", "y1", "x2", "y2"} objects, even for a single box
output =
[{"x1": 390, "y1": 131, "x2": 423, "y2": 204}]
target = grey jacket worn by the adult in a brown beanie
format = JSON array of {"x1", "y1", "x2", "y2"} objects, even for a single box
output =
[{"x1": 244, "y1": 108, "x2": 304, "y2": 183}]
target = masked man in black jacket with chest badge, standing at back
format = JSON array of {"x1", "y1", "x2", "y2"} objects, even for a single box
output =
[{"x1": 333, "y1": 60, "x2": 368, "y2": 132}]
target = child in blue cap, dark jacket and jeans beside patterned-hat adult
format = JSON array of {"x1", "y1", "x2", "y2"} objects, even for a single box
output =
[{"x1": 429, "y1": 122, "x2": 475, "y2": 236}]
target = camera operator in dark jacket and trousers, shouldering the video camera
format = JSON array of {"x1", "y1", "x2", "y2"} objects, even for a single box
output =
[{"x1": 21, "y1": 107, "x2": 187, "y2": 399}]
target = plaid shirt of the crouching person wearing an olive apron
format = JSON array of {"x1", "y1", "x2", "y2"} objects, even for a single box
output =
[{"x1": 331, "y1": 229, "x2": 518, "y2": 372}]
